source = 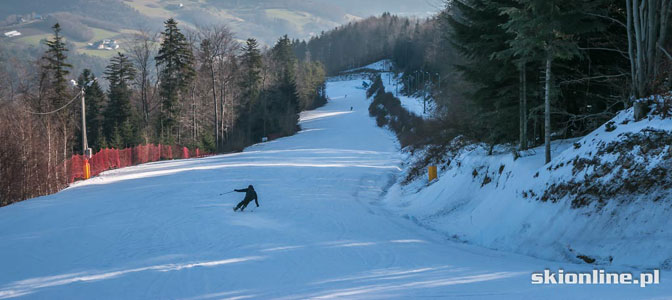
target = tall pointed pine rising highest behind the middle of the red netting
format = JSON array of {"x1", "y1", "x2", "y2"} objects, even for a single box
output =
[{"x1": 156, "y1": 18, "x2": 195, "y2": 143}]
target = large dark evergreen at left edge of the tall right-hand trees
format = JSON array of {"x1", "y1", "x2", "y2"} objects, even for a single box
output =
[{"x1": 442, "y1": 0, "x2": 518, "y2": 148}]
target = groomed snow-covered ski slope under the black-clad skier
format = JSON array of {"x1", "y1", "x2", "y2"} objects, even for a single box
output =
[{"x1": 0, "y1": 79, "x2": 672, "y2": 299}]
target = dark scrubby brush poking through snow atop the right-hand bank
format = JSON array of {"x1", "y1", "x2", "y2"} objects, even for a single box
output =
[{"x1": 539, "y1": 128, "x2": 672, "y2": 208}]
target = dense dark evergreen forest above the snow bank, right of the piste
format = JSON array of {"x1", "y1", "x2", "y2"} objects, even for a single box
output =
[{"x1": 294, "y1": 0, "x2": 672, "y2": 161}]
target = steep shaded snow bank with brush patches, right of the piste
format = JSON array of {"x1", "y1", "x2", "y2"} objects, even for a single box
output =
[{"x1": 385, "y1": 104, "x2": 672, "y2": 269}]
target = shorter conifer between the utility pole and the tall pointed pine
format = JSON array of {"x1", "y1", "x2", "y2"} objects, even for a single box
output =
[{"x1": 105, "y1": 53, "x2": 136, "y2": 146}]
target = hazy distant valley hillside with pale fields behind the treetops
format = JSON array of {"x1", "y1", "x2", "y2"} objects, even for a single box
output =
[{"x1": 0, "y1": 0, "x2": 437, "y2": 45}]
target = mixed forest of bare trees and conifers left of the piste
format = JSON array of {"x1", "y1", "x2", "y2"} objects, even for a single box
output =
[{"x1": 0, "y1": 19, "x2": 326, "y2": 205}]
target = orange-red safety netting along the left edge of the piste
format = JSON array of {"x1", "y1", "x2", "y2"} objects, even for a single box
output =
[{"x1": 69, "y1": 144, "x2": 208, "y2": 183}]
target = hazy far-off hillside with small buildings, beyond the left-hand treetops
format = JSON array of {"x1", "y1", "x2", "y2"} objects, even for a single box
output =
[{"x1": 0, "y1": 0, "x2": 440, "y2": 50}]
